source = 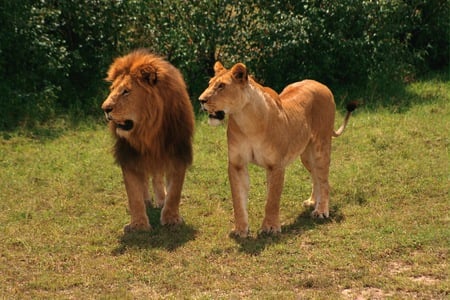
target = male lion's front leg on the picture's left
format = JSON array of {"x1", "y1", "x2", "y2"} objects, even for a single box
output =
[{"x1": 122, "y1": 167, "x2": 151, "y2": 232}]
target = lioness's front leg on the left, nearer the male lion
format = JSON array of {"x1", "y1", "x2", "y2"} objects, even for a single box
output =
[{"x1": 228, "y1": 163, "x2": 250, "y2": 238}]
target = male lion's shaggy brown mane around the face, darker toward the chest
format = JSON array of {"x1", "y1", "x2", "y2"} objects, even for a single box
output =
[{"x1": 107, "y1": 49, "x2": 194, "y2": 170}]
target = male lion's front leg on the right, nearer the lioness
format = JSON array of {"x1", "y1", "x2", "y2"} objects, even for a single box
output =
[{"x1": 161, "y1": 165, "x2": 186, "y2": 225}]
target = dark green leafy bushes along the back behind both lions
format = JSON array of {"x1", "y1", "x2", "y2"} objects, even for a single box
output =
[{"x1": 0, "y1": 0, "x2": 450, "y2": 129}]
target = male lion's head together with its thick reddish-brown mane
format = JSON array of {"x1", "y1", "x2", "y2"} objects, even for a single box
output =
[{"x1": 102, "y1": 49, "x2": 194, "y2": 165}]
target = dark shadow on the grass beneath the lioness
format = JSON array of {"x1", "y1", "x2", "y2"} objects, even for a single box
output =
[{"x1": 230, "y1": 206, "x2": 345, "y2": 256}]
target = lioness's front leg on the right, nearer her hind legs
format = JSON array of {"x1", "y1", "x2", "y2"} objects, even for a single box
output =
[{"x1": 261, "y1": 167, "x2": 285, "y2": 233}]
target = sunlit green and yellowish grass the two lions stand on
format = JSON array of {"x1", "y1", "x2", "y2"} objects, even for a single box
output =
[{"x1": 0, "y1": 79, "x2": 450, "y2": 299}]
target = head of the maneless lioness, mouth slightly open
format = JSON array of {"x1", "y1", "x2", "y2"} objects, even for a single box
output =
[{"x1": 199, "y1": 62, "x2": 248, "y2": 126}]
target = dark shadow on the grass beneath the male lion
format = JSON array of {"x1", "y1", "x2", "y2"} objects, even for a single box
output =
[{"x1": 111, "y1": 207, "x2": 197, "y2": 255}]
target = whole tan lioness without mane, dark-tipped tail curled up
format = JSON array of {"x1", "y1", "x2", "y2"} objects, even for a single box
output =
[{"x1": 199, "y1": 62, "x2": 356, "y2": 237}]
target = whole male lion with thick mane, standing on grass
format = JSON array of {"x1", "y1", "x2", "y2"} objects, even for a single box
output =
[{"x1": 102, "y1": 49, "x2": 194, "y2": 232}]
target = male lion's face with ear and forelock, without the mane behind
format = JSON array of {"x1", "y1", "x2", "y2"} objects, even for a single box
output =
[{"x1": 102, "y1": 50, "x2": 161, "y2": 138}]
